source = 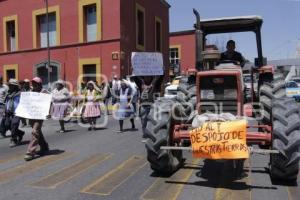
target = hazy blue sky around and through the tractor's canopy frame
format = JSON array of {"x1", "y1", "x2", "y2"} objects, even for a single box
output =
[{"x1": 168, "y1": 0, "x2": 300, "y2": 61}]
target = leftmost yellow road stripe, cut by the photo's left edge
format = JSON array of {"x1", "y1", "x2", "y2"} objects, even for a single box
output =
[{"x1": 0, "y1": 153, "x2": 73, "y2": 183}]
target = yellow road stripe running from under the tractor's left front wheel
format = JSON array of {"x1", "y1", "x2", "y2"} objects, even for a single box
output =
[{"x1": 141, "y1": 159, "x2": 200, "y2": 200}]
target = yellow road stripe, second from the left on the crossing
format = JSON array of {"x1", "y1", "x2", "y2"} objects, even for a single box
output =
[{"x1": 30, "y1": 154, "x2": 111, "y2": 189}]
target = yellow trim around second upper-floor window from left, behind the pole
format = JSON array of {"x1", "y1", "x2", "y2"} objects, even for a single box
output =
[{"x1": 32, "y1": 5, "x2": 60, "y2": 48}]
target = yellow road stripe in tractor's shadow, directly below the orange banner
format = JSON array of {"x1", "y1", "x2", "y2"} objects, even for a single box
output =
[{"x1": 215, "y1": 160, "x2": 251, "y2": 200}]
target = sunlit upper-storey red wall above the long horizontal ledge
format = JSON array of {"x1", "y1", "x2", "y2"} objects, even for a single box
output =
[{"x1": 0, "y1": 0, "x2": 120, "y2": 52}]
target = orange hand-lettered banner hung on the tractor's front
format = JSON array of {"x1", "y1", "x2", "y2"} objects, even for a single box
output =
[{"x1": 190, "y1": 120, "x2": 249, "y2": 159}]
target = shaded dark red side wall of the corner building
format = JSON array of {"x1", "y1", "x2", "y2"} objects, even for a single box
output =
[{"x1": 121, "y1": 0, "x2": 169, "y2": 76}]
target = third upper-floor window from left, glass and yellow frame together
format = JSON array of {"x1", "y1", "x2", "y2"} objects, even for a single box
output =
[{"x1": 79, "y1": 0, "x2": 101, "y2": 42}]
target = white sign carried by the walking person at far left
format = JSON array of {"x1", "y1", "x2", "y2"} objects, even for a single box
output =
[{"x1": 16, "y1": 92, "x2": 52, "y2": 120}]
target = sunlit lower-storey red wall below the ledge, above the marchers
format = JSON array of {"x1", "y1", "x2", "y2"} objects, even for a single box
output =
[{"x1": 0, "y1": 42, "x2": 120, "y2": 85}]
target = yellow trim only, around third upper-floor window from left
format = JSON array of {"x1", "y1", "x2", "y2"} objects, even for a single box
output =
[{"x1": 78, "y1": 0, "x2": 102, "y2": 42}]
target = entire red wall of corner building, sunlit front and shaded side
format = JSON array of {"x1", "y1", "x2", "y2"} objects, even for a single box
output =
[{"x1": 0, "y1": 0, "x2": 169, "y2": 85}]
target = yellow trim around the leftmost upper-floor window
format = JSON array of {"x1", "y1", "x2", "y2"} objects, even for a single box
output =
[{"x1": 3, "y1": 15, "x2": 19, "y2": 52}]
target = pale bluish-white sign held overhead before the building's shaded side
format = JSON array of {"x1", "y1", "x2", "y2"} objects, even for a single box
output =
[{"x1": 131, "y1": 52, "x2": 164, "y2": 76}]
